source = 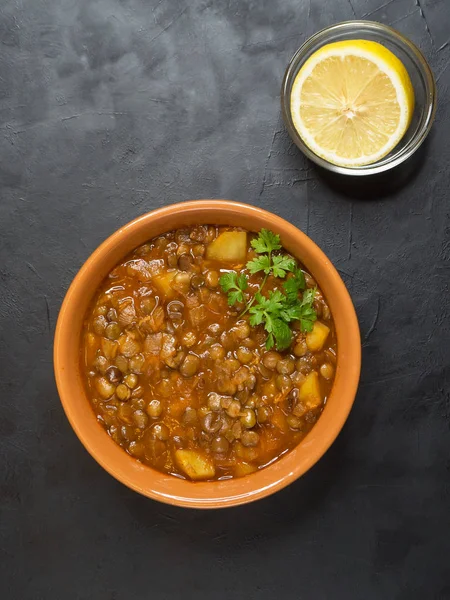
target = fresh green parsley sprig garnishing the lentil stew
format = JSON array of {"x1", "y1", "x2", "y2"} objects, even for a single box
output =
[{"x1": 220, "y1": 229, "x2": 317, "y2": 350}]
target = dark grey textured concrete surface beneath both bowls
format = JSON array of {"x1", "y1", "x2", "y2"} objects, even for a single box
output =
[{"x1": 0, "y1": 0, "x2": 450, "y2": 600}]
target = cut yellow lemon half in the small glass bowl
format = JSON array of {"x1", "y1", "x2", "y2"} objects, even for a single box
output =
[{"x1": 291, "y1": 40, "x2": 414, "y2": 167}]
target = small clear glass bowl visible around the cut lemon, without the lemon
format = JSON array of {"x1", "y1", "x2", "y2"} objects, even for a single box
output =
[{"x1": 282, "y1": 21, "x2": 436, "y2": 175}]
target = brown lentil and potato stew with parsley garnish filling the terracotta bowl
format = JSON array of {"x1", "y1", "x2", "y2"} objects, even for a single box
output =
[{"x1": 82, "y1": 225, "x2": 336, "y2": 480}]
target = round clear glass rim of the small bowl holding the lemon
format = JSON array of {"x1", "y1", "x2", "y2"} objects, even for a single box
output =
[{"x1": 281, "y1": 20, "x2": 437, "y2": 176}]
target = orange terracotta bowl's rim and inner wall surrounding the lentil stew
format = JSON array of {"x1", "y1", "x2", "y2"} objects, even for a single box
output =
[{"x1": 54, "y1": 200, "x2": 361, "y2": 508}]
